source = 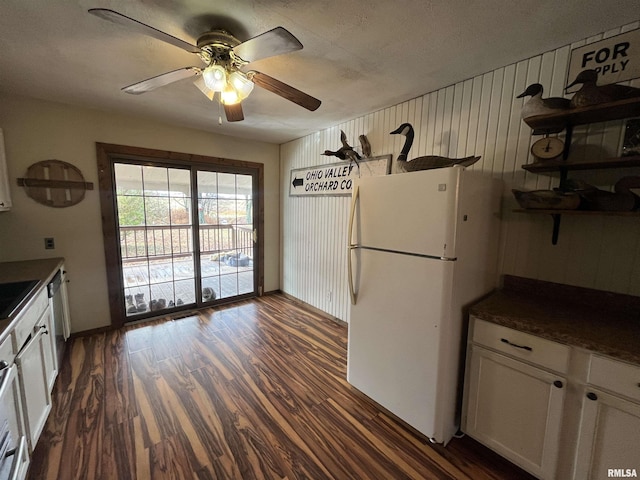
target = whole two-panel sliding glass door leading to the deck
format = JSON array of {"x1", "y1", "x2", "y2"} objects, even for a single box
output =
[{"x1": 96, "y1": 142, "x2": 261, "y2": 323}]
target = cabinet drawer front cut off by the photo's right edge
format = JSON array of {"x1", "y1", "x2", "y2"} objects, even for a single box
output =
[{"x1": 589, "y1": 355, "x2": 640, "y2": 401}]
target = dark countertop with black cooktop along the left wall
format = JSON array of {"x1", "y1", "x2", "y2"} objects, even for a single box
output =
[{"x1": 0, "y1": 258, "x2": 64, "y2": 342}]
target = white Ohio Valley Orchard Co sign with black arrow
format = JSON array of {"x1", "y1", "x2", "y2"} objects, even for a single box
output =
[{"x1": 289, "y1": 155, "x2": 391, "y2": 196}]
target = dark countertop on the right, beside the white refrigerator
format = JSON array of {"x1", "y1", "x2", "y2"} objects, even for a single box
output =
[{"x1": 470, "y1": 275, "x2": 640, "y2": 365}]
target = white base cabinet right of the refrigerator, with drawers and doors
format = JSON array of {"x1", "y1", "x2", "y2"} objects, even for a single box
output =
[{"x1": 462, "y1": 317, "x2": 640, "y2": 480}]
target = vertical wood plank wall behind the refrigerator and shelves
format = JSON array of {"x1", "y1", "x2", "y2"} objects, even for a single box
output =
[{"x1": 281, "y1": 22, "x2": 640, "y2": 321}]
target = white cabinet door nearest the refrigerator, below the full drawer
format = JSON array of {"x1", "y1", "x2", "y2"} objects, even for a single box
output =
[{"x1": 463, "y1": 345, "x2": 565, "y2": 478}]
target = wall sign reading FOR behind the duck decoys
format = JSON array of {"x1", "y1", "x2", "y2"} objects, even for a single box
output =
[{"x1": 567, "y1": 29, "x2": 640, "y2": 92}]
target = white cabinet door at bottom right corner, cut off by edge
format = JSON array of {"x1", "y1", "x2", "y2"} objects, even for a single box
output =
[{"x1": 573, "y1": 388, "x2": 640, "y2": 480}]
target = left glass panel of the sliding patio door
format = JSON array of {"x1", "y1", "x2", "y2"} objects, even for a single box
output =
[{"x1": 114, "y1": 163, "x2": 198, "y2": 317}]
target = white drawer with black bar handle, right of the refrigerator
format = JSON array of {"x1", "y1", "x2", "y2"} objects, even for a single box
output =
[{"x1": 472, "y1": 318, "x2": 571, "y2": 373}]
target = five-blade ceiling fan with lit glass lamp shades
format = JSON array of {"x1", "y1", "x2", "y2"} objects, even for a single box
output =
[{"x1": 89, "y1": 8, "x2": 321, "y2": 122}]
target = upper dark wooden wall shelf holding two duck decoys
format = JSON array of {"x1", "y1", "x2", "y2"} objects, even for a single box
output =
[{"x1": 524, "y1": 97, "x2": 640, "y2": 133}]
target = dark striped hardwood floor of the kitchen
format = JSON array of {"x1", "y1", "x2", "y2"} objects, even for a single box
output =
[{"x1": 29, "y1": 295, "x2": 532, "y2": 480}]
